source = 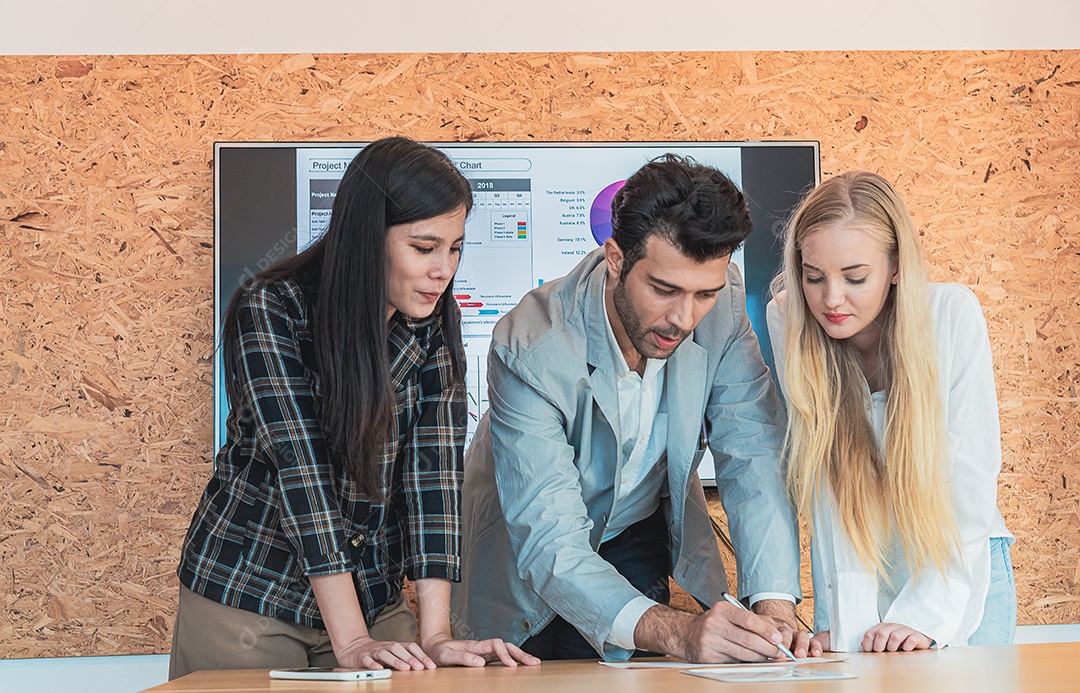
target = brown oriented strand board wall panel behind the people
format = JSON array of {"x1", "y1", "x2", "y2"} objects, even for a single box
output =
[{"x1": 0, "y1": 52, "x2": 1080, "y2": 657}]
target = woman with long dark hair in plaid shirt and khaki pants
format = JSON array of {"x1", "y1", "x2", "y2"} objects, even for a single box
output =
[{"x1": 170, "y1": 137, "x2": 539, "y2": 678}]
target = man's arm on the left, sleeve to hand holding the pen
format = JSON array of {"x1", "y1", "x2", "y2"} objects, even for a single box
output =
[{"x1": 488, "y1": 343, "x2": 812, "y2": 662}]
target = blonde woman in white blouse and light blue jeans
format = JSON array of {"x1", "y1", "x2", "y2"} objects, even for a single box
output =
[{"x1": 768, "y1": 173, "x2": 1016, "y2": 654}]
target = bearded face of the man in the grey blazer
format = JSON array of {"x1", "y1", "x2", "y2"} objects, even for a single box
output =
[{"x1": 605, "y1": 235, "x2": 731, "y2": 358}]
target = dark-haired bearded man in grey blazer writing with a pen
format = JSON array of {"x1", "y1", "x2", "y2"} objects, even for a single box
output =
[{"x1": 453, "y1": 155, "x2": 809, "y2": 662}]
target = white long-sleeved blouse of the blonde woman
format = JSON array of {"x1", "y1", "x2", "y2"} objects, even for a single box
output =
[{"x1": 767, "y1": 284, "x2": 1012, "y2": 652}]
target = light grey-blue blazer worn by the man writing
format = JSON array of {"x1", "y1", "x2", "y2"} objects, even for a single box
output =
[{"x1": 451, "y1": 248, "x2": 801, "y2": 660}]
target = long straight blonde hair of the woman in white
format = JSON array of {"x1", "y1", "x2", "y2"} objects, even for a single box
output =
[{"x1": 773, "y1": 172, "x2": 959, "y2": 579}]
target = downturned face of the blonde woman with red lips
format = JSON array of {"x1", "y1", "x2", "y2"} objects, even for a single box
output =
[{"x1": 802, "y1": 223, "x2": 897, "y2": 350}]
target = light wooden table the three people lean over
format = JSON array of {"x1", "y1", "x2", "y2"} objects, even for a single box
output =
[{"x1": 143, "y1": 642, "x2": 1080, "y2": 693}]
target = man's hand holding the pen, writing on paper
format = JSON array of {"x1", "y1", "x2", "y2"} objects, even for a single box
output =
[{"x1": 634, "y1": 601, "x2": 783, "y2": 664}]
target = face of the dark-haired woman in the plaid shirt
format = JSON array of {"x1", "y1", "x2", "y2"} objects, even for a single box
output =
[{"x1": 387, "y1": 207, "x2": 465, "y2": 320}]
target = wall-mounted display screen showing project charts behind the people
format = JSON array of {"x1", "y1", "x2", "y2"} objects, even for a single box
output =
[{"x1": 214, "y1": 142, "x2": 820, "y2": 479}]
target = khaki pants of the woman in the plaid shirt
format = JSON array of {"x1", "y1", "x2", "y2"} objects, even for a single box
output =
[{"x1": 168, "y1": 585, "x2": 417, "y2": 680}]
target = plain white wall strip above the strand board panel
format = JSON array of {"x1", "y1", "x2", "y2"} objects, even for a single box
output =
[{"x1": 0, "y1": 0, "x2": 1080, "y2": 55}]
